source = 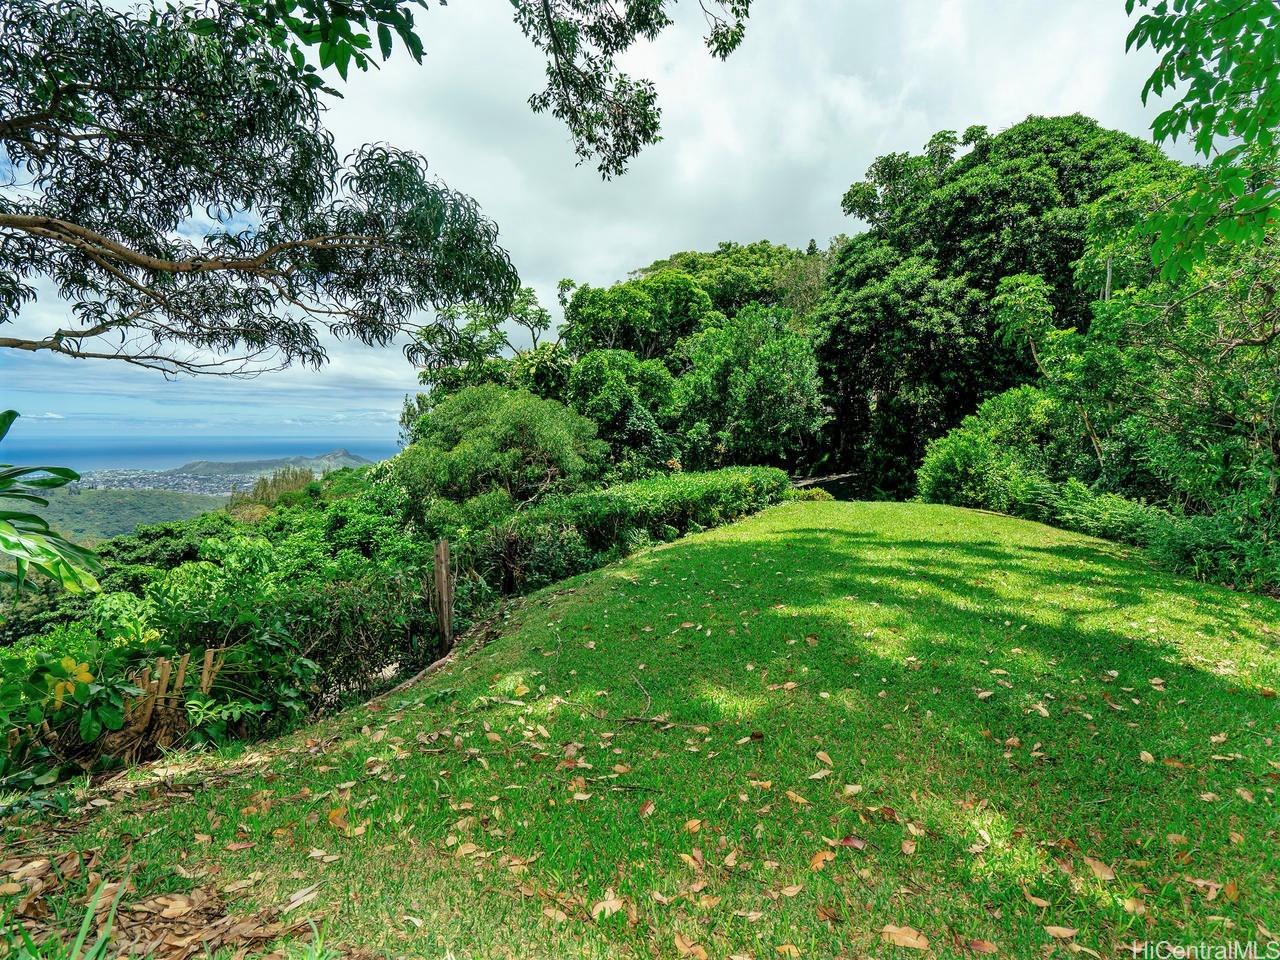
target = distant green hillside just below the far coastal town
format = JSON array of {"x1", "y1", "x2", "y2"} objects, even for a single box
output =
[{"x1": 40, "y1": 489, "x2": 227, "y2": 544}]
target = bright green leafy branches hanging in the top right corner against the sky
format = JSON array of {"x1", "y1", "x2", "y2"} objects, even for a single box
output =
[{"x1": 1125, "y1": 0, "x2": 1280, "y2": 279}]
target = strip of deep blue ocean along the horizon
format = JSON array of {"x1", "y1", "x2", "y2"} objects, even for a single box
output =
[{"x1": 0, "y1": 430, "x2": 399, "y2": 474}]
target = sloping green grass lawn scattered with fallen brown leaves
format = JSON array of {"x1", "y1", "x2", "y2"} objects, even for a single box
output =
[{"x1": 0, "y1": 503, "x2": 1280, "y2": 960}]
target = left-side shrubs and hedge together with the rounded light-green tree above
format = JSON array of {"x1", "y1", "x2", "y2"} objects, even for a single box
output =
[{"x1": 0, "y1": 448, "x2": 790, "y2": 787}]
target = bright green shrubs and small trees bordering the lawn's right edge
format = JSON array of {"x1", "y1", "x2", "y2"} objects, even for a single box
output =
[{"x1": 918, "y1": 158, "x2": 1280, "y2": 590}]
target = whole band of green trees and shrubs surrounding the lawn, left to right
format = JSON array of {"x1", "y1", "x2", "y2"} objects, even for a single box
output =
[{"x1": 10, "y1": 86, "x2": 1280, "y2": 785}]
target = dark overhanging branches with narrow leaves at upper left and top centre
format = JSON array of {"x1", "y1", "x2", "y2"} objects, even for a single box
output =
[{"x1": 0, "y1": 0, "x2": 750, "y2": 374}]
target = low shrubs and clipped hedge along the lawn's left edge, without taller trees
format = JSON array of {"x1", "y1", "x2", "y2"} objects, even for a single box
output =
[{"x1": 0, "y1": 468, "x2": 790, "y2": 787}]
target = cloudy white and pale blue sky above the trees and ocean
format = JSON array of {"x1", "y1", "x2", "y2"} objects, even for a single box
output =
[{"x1": 0, "y1": 0, "x2": 1177, "y2": 448}]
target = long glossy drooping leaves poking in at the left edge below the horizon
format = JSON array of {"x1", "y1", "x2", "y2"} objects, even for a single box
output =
[{"x1": 0, "y1": 410, "x2": 100, "y2": 593}]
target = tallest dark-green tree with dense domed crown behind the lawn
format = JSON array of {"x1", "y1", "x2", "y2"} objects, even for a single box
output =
[{"x1": 814, "y1": 115, "x2": 1176, "y2": 493}]
